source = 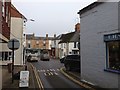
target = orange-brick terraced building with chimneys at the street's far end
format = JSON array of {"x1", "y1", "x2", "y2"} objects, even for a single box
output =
[{"x1": 26, "y1": 33, "x2": 58, "y2": 58}]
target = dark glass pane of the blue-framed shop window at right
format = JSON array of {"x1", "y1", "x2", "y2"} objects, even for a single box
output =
[{"x1": 107, "y1": 41, "x2": 120, "y2": 71}]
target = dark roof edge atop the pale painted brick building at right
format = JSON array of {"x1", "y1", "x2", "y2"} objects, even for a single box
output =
[{"x1": 78, "y1": 1, "x2": 104, "y2": 14}]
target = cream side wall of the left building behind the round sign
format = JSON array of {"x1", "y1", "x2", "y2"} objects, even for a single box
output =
[{"x1": 10, "y1": 17, "x2": 23, "y2": 65}]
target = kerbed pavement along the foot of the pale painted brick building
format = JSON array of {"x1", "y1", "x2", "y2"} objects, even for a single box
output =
[{"x1": 60, "y1": 67, "x2": 110, "y2": 90}]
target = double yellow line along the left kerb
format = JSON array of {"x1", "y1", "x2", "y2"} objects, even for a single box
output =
[{"x1": 30, "y1": 63, "x2": 44, "y2": 90}]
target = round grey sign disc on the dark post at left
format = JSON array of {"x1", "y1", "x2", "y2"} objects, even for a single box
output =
[{"x1": 8, "y1": 39, "x2": 20, "y2": 50}]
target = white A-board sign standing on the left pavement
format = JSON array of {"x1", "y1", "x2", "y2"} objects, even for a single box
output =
[{"x1": 19, "y1": 71, "x2": 29, "y2": 87}]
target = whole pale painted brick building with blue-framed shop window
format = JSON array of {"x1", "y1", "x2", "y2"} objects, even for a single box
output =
[{"x1": 78, "y1": 0, "x2": 120, "y2": 89}]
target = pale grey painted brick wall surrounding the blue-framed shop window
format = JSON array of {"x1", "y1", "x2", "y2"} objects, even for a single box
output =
[{"x1": 80, "y1": 2, "x2": 118, "y2": 88}]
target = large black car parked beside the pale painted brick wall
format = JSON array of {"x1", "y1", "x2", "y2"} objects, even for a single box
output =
[{"x1": 64, "y1": 55, "x2": 80, "y2": 71}]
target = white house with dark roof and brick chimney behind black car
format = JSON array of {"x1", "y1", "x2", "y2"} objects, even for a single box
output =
[{"x1": 58, "y1": 23, "x2": 80, "y2": 58}]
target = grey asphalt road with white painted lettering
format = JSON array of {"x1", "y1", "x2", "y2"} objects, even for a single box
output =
[{"x1": 32, "y1": 59, "x2": 85, "y2": 90}]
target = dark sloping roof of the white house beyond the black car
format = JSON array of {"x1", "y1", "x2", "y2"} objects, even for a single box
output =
[{"x1": 59, "y1": 32, "x2": 80, "y2": 44}]
